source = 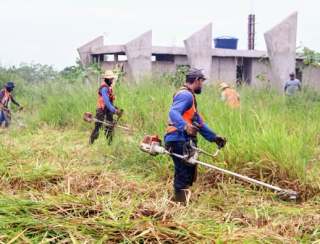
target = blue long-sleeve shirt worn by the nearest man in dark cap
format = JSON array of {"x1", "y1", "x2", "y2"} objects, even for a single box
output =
[{"x1": 164, "y1": 91, "x2": 216, "y2": 142}]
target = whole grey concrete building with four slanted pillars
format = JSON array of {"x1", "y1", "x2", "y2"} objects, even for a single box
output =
[{"x1": 78, "y1": 13, "x2": 320, "y2": 90}]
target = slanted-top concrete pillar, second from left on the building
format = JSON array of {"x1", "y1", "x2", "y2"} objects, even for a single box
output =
[{"x1": 125, "y1": 30, "x2": 152, "y2": 81}]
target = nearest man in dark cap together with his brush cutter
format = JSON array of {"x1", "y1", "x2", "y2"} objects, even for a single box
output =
[{"x1": 140, "y1": 69, "x2": 297, "y2": 205}]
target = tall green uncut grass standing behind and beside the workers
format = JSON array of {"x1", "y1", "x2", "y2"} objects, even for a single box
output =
[{"x1": 14, "y1": 79, "x2": 320, "y2": 185}]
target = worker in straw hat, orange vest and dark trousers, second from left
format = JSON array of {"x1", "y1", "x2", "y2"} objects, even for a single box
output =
[{"x1": 89, "y1": 70, "x2": 122, "y2": 144}]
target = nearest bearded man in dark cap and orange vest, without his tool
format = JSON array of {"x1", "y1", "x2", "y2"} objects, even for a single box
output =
[{"x1": 164, "y1": 69, "x2": 226, "y2": 204}]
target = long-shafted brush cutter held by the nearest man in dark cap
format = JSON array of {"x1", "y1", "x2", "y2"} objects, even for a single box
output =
[{"x1": 140, "y1": 136, "x2": 298, "y2": 201}]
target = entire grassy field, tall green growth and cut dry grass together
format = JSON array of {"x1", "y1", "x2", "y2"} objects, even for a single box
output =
[{"x1": 0, "y1": 70, "x2": 320, "y2": 243}]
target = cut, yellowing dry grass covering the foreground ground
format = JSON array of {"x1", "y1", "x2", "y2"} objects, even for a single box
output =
[{"x1": 0, "y1": 127, "x2": 320, "y2": 243}]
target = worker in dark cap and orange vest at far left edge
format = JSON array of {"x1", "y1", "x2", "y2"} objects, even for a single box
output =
[{"x1": 0, "y1": 81, "x2": 22, "y2": 127}]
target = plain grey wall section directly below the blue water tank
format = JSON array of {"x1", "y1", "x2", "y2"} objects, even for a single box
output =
[{"x1": 211, "y1": 57, "x2": 237, "y2": 85}]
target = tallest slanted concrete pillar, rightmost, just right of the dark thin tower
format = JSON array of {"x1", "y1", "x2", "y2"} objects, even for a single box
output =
[{"x1": 264, "y1": 12, "x2": 298, "y2": 91}]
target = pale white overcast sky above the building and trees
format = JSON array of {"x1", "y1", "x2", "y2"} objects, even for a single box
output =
[{"x1": 0, "y1": 0, "x2": 320, "y2": 69}]
